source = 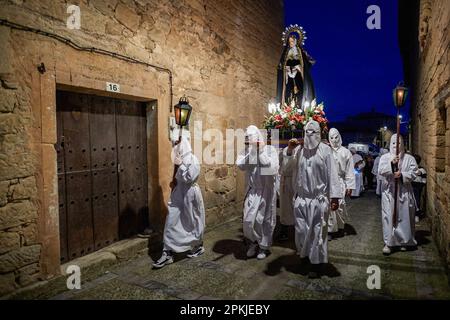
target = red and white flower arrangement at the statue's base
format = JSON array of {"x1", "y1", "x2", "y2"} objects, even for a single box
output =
[{"x1": 263, "y1": 101, "x2": 328, "y2": 138}]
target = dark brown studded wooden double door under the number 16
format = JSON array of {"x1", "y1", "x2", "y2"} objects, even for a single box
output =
[{"x1": 56, "y1": 91, "x2": 148, "y2": 261}]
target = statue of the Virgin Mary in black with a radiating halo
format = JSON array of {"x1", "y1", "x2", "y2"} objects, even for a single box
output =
[{"x1": 277, "y1": 25, "x2": 316, "y2": 110}]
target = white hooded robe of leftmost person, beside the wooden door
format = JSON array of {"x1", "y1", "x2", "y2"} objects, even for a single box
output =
[{"x1": 164, "y1": 153, "x2": 205, "y2": 252}]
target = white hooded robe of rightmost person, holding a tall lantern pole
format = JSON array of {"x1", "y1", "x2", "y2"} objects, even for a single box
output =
[{"x1": 378, "y1": 153, "x2": 417, "y2": 247}]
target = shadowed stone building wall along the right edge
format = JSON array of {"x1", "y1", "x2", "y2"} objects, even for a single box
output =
[{"x1": 399, "y1": 0, "x2": 450, "y2": 274}]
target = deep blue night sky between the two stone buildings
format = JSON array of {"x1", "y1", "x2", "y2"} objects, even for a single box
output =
[{"x1": 284, "y1": 0, "x2": 407, "y2": 121}]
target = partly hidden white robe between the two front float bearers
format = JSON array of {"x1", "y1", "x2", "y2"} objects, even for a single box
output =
[{"x1": 279, "y1": 147, "x2": 300, "y2": 226}]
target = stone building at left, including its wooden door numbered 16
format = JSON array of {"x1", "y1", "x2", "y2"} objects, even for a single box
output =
[{"x1": 0, "y1": 0, "x2": 284, "y2": 296}]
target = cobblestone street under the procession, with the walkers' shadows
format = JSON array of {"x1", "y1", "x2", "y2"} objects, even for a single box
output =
[{"x1": 8, "y1": 192, "x2": 450, "y2": 299}]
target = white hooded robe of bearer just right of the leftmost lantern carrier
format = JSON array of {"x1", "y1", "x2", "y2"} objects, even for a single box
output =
[{"x1": 236, "y1": 146, "x2": 279, "y2": 249}]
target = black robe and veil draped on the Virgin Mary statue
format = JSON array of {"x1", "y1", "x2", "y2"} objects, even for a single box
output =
[{"x1": 277, "y1": 46, "x2": 316, "y2": 107}]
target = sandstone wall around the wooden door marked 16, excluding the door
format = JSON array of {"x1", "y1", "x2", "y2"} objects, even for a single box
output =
[{"x1": 0, "y1": 0, "x2": 283, "y2": 296}]
